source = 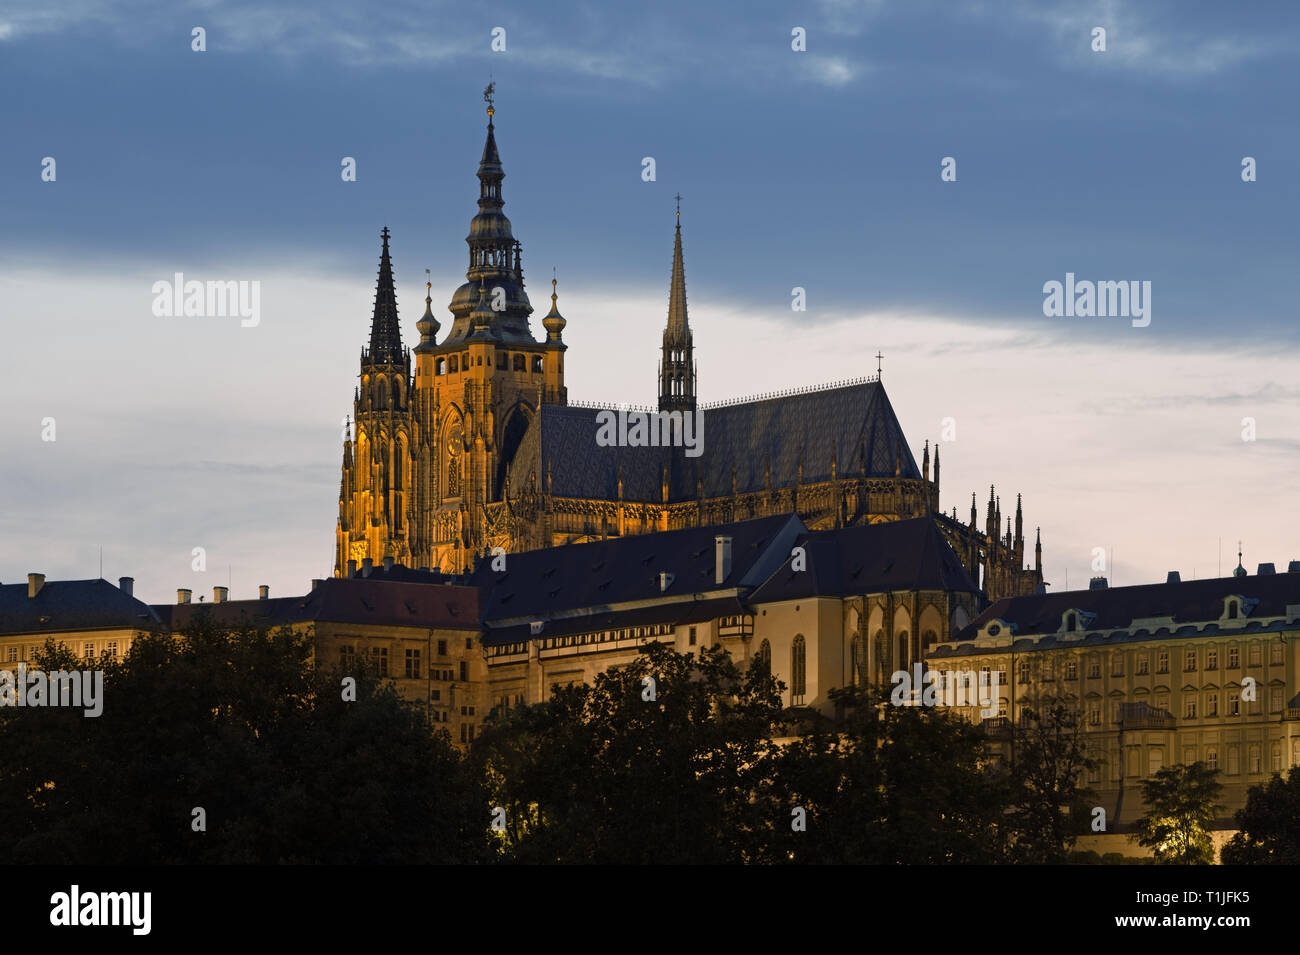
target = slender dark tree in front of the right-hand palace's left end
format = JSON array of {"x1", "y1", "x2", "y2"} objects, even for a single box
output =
[{"x1": 1010, "y1": 696, "x2": 1097, "y2": 864}]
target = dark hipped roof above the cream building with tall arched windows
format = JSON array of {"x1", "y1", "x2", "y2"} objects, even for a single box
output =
[{"x1": 749, "y1": 517, "x2": 979, "y2": 604}]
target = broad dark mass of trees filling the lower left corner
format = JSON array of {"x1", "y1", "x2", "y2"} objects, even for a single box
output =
[{"x1": 0, "y1": 615, "x2": 489, "y2": 864}]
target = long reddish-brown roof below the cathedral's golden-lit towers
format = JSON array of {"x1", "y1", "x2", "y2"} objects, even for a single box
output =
[{"x1": 153, "y1": 577, "x2": 481, "y2": 630}]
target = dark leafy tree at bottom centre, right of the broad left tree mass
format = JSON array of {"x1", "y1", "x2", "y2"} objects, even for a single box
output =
[{"x1": 472, "y1": 643, "x2": 781, "y2": 864}]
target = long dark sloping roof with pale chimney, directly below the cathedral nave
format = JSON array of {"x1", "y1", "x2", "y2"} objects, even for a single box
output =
[{"x1": 471, "y1": 515, "x2": 802, "y2": 621}]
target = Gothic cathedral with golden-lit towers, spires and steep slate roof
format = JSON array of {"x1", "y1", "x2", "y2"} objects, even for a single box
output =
[{"x1": 334, "y1": 99, "x2": 1043, "y2": 599}]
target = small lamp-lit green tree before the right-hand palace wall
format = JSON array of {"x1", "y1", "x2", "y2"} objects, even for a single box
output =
[{"x1": 1130, "y1": 763, "x2": 1223, "y2": 865}]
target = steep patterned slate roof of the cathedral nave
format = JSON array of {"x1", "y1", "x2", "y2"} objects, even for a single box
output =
[{"x1": 510, "y1": 381, "x2": 920, "y2": 502}]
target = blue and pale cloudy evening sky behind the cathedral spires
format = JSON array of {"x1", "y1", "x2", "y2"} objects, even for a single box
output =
[{"x1": 0, "y1": 0, "x2": 1300, "y2": 602}]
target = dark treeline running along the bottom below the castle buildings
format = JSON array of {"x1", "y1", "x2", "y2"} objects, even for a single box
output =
[{"x1": 0, "y1": 617, "x2": 1294, "y2": 864}]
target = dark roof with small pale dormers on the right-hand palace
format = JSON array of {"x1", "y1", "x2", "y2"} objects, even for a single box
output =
[{"x1": 956, "y1": 573, "x2": 1300, "y2": 646}]
